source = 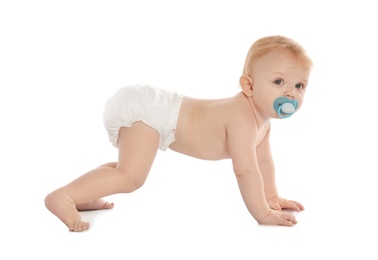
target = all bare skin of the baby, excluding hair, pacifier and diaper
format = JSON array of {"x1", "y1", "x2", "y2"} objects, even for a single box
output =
[{"x1": 45, "y1": 37, "x2": 310, "y2": 231}]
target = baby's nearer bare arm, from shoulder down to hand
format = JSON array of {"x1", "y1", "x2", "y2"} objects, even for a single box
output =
[{"x1": 227, "y1": 122, "x2": 296, "y2": 226}]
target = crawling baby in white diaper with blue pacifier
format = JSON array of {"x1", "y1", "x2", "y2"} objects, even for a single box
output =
[{"x1": 45, "y1": 36, "x2": 312, "y2": 231}]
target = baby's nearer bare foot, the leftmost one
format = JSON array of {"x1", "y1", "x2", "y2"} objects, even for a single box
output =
[{"x1": 45, "y1": 190, "x2": 89, "y2": 232}]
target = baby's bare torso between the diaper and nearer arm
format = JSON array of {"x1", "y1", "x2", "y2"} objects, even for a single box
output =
[{"x1": 169, "y1": 97, "x2": 238, "y2": 160}]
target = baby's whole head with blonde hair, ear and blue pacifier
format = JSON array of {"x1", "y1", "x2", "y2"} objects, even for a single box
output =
[{"x1": 240, "y1": 36, "x2": 312, "y2": 118}]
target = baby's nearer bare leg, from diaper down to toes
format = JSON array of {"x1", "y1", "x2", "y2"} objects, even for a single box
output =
[{"x1": 45, "y1": 122, "x2": 159, "y2": 231}]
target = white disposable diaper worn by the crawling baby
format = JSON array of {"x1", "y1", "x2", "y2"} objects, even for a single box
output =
[{"x1": 103, "y1": 85, "x2": 183, "y2": 151}]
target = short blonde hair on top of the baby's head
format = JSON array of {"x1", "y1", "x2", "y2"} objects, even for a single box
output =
[{"x1": 243, "y1": 35, "x2": 313, "y2": 76}]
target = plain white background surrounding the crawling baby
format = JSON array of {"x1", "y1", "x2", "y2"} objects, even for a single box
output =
[{"x1": 0, "y1": 0, "x2": 378, "y2": 259}]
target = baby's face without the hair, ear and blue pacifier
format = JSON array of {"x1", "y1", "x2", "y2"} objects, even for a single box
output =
[{"x1": 252, "y1": 51, "x2": 310, "y2": 118}]
